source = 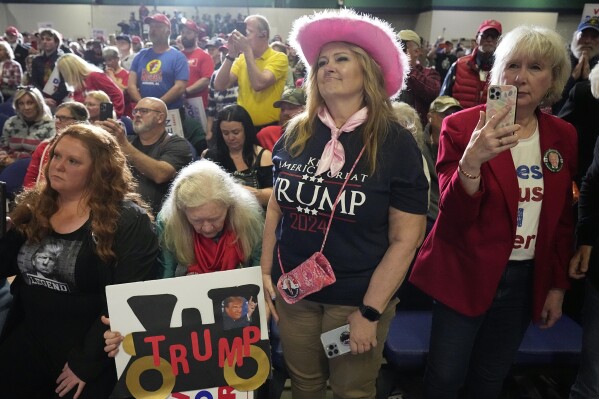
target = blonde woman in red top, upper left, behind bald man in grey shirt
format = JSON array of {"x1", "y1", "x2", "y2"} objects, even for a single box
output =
[{"x1": 56, "y1": 54, "x2": 125, "y2": 118}]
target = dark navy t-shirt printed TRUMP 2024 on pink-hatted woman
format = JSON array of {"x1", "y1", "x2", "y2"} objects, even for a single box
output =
[{"x1": 272, "y1": 120, "x2": 428, "y2": 306}]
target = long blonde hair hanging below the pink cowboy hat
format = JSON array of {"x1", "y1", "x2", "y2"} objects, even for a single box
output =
[{"x1": 285, "y1": 42, "x2": 396, "y2": 174}]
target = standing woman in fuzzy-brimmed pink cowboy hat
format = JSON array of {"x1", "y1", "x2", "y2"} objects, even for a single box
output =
[{"x1": 261, "y1": 9, "x2": 428, "y2": 399}]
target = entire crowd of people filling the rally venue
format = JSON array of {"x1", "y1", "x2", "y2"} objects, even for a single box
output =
[{"x1": 0, "y1": 6, "x2": 599, "y2": 399}]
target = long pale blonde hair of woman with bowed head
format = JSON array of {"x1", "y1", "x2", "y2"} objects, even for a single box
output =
[{"x1": 158, "y1": 159, "x2": 264, "y2": 265}]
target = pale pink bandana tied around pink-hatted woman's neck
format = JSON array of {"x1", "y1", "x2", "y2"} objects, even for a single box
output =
[{"x1": 314, "y1": 105, "x2": 368, "y2": 176}]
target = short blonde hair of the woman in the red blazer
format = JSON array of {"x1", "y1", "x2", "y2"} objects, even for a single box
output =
[{"x1": 490, "y1": 26, "x2": 572, "y2": 105}]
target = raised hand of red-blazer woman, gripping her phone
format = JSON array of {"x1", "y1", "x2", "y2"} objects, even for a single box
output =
[{"x1": 460, "y1": 107, "x2": 520, "y2": 176}]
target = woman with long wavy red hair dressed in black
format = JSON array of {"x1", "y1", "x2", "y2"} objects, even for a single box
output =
[{"x1": 0, "y1": 125, "x2": 158, "y2": 398}]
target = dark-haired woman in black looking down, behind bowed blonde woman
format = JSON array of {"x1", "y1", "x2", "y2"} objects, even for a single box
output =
[{"x1": 202, "y1": 105, "x2": 272, "y2": 206}]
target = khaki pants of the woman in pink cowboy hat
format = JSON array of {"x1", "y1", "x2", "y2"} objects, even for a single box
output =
[{"x1": 276, "y1": 297, "x2": 398, "y2": 399}]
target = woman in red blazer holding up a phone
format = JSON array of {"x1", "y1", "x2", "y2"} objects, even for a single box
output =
[{"x1": 410, "y1": 27, "x2": 577, "y2": 398}]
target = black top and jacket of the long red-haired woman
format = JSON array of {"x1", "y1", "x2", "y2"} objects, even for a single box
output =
[{"x1": 0, "y1": 202, "x2": 158, "y2": 381}]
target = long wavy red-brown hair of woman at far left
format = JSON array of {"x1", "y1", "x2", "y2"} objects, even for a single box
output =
[{"x1": 11, "y1": 124, "x2": 151, "y2": 262}]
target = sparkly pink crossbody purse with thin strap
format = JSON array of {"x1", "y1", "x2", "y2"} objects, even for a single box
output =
[{"x1": 277, "y1": 147, "x2": 366, "y2": 304}]
